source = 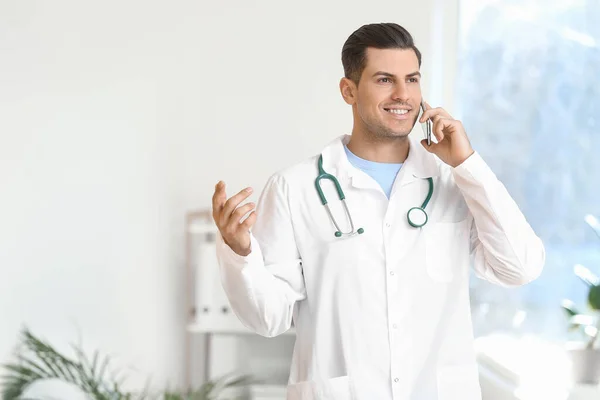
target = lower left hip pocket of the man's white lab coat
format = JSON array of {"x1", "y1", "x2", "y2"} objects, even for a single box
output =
[{"x1": 287, "y1": 376, "x2": 354, "y2": 400}]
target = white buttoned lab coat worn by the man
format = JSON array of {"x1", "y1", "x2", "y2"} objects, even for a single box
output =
[{"x1": 217, "y1": 136, "x2": 545, "y2": 400}]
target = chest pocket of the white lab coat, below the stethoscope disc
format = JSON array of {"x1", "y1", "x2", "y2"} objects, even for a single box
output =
[{"x1": 423, "y1": 219, "x2": 469, "y2": 283}]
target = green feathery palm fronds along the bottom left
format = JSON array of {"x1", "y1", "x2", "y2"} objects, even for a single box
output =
[{"x1": 0, "y1": 328, "x2": 254, "y2": 400}]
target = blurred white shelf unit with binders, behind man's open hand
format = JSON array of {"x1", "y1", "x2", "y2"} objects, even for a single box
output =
[{"x1": 185, "y1": 210, "x2": 296, "y2": 390}]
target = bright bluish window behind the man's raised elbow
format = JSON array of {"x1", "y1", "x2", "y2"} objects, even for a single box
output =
[{"x1": 457, "y1": 0, "x2": 600, "y2": 340}]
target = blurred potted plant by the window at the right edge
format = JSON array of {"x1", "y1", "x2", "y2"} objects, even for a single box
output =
[{"x1": 562, "y1": 215, "x2": 600, "y2": 385}]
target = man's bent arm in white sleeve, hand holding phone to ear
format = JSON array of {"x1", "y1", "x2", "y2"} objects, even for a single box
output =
[{"x1": 420, "y1": 103, "x2": 546, "y2": 286}]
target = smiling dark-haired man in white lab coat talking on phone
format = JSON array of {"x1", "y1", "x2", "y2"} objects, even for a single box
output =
[{"x1": 213, "y1": 23, "x2": 545, "y2": 400}]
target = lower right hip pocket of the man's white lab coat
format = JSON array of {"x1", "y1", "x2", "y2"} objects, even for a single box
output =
[{"x1": 437, "y1": 364, "x2": 481, "y2": 400}]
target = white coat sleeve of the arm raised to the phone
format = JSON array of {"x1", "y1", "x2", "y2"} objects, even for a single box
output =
[{"x1": 453, "y1": 152, "x2": 546, "y2": 286}]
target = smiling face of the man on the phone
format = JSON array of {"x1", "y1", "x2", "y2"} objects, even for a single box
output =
[{"x1": 340, "y1": 48, "x2": 421, "y2": 138}]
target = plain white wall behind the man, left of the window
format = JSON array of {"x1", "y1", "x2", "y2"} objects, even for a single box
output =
[{"x1": 0, "y1": 0, "x2": 456, "y2": 394}]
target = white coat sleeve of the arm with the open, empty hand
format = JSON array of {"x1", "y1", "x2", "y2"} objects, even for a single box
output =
[{"x1": 217, "y1": 175, "x2": 306, "y2": 337}]
